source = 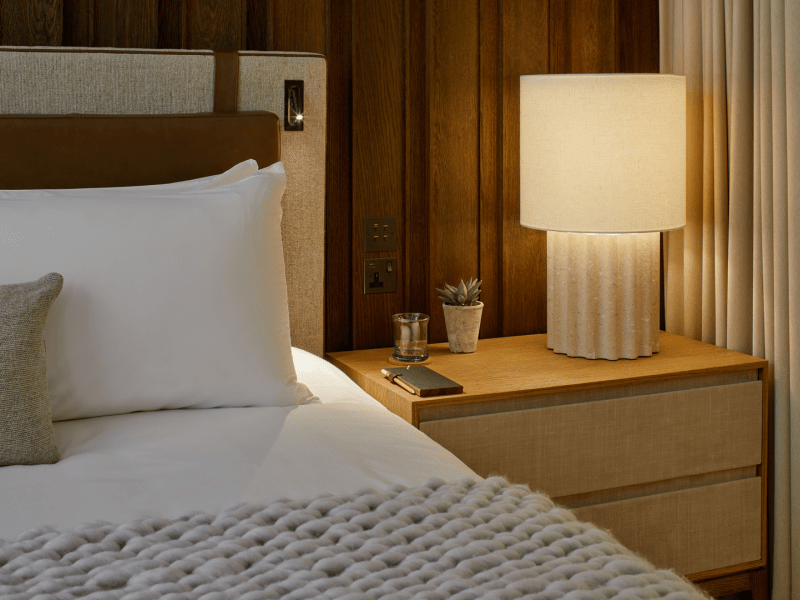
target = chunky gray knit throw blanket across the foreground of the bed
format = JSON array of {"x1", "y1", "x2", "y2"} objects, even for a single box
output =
[{"x1": 0, "y1": 478, "x2": 705, "y2": 600}]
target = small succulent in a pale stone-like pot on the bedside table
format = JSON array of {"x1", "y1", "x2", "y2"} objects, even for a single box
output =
[{"x1": 436, "y1": 279, "x2": 483, "y2": 354}]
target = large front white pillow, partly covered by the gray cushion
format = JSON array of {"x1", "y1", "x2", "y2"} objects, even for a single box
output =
[{"x1": 0, "y1": 163, "x2": 312, "y2": 421}]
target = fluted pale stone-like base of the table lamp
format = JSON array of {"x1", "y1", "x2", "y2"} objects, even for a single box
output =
[{"x1": 547, "y1": 231, "x2": 660, "y2": 360}]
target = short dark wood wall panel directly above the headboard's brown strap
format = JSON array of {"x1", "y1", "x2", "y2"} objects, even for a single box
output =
[{"x1": 186, "y1": 0, "x2": 246, "y2": 50}]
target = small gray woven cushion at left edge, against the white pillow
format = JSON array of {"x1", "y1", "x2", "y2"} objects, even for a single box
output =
[{"x1": 0, "y1": 273, "x2": 64, "y2": 467}]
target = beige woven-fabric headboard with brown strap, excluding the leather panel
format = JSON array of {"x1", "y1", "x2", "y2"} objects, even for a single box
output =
[{"x1": 0, "y1": 47, "x2": 326, "y2": 356}]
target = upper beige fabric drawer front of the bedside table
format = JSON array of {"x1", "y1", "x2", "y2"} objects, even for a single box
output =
[{"x1": 420, "y1": 381, "x2": 762, "y2": 498}]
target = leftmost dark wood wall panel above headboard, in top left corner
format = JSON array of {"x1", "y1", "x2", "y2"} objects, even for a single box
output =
[{"x1": 0, "y1": 0, "x2": 64, "y2": 46}]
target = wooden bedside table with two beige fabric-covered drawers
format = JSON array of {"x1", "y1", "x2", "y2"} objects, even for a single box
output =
[{"x1": 328, "y1": 332, "x2": 769, "y2": 598}]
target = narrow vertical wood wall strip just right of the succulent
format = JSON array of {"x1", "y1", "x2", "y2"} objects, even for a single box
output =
[{"x1": 479, "y1": 0, "x2": 503, "y2": 338}]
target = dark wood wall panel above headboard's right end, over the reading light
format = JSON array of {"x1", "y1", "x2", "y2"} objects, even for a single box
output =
[{"x1": 272, "y1": 0, "x2": 326, "y2": 54}]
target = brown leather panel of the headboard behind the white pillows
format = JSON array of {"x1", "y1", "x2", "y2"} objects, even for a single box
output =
[{"x1": 0, "y1": 111, "x2": 280, "y2": 189}]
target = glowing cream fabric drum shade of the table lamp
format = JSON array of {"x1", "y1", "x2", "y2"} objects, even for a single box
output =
[{"x1": 520, "y1": 75, "x2": 686, "y2": 233}]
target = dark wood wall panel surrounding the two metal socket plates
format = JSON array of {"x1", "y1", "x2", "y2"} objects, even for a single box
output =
[{"x1": 351, "y1": 0, "x2": 409, "y2": 348}]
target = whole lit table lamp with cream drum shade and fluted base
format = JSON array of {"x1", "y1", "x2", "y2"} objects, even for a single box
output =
[{"x1": 520, "y1": 74, "x2": 686, "y2": 360}]
